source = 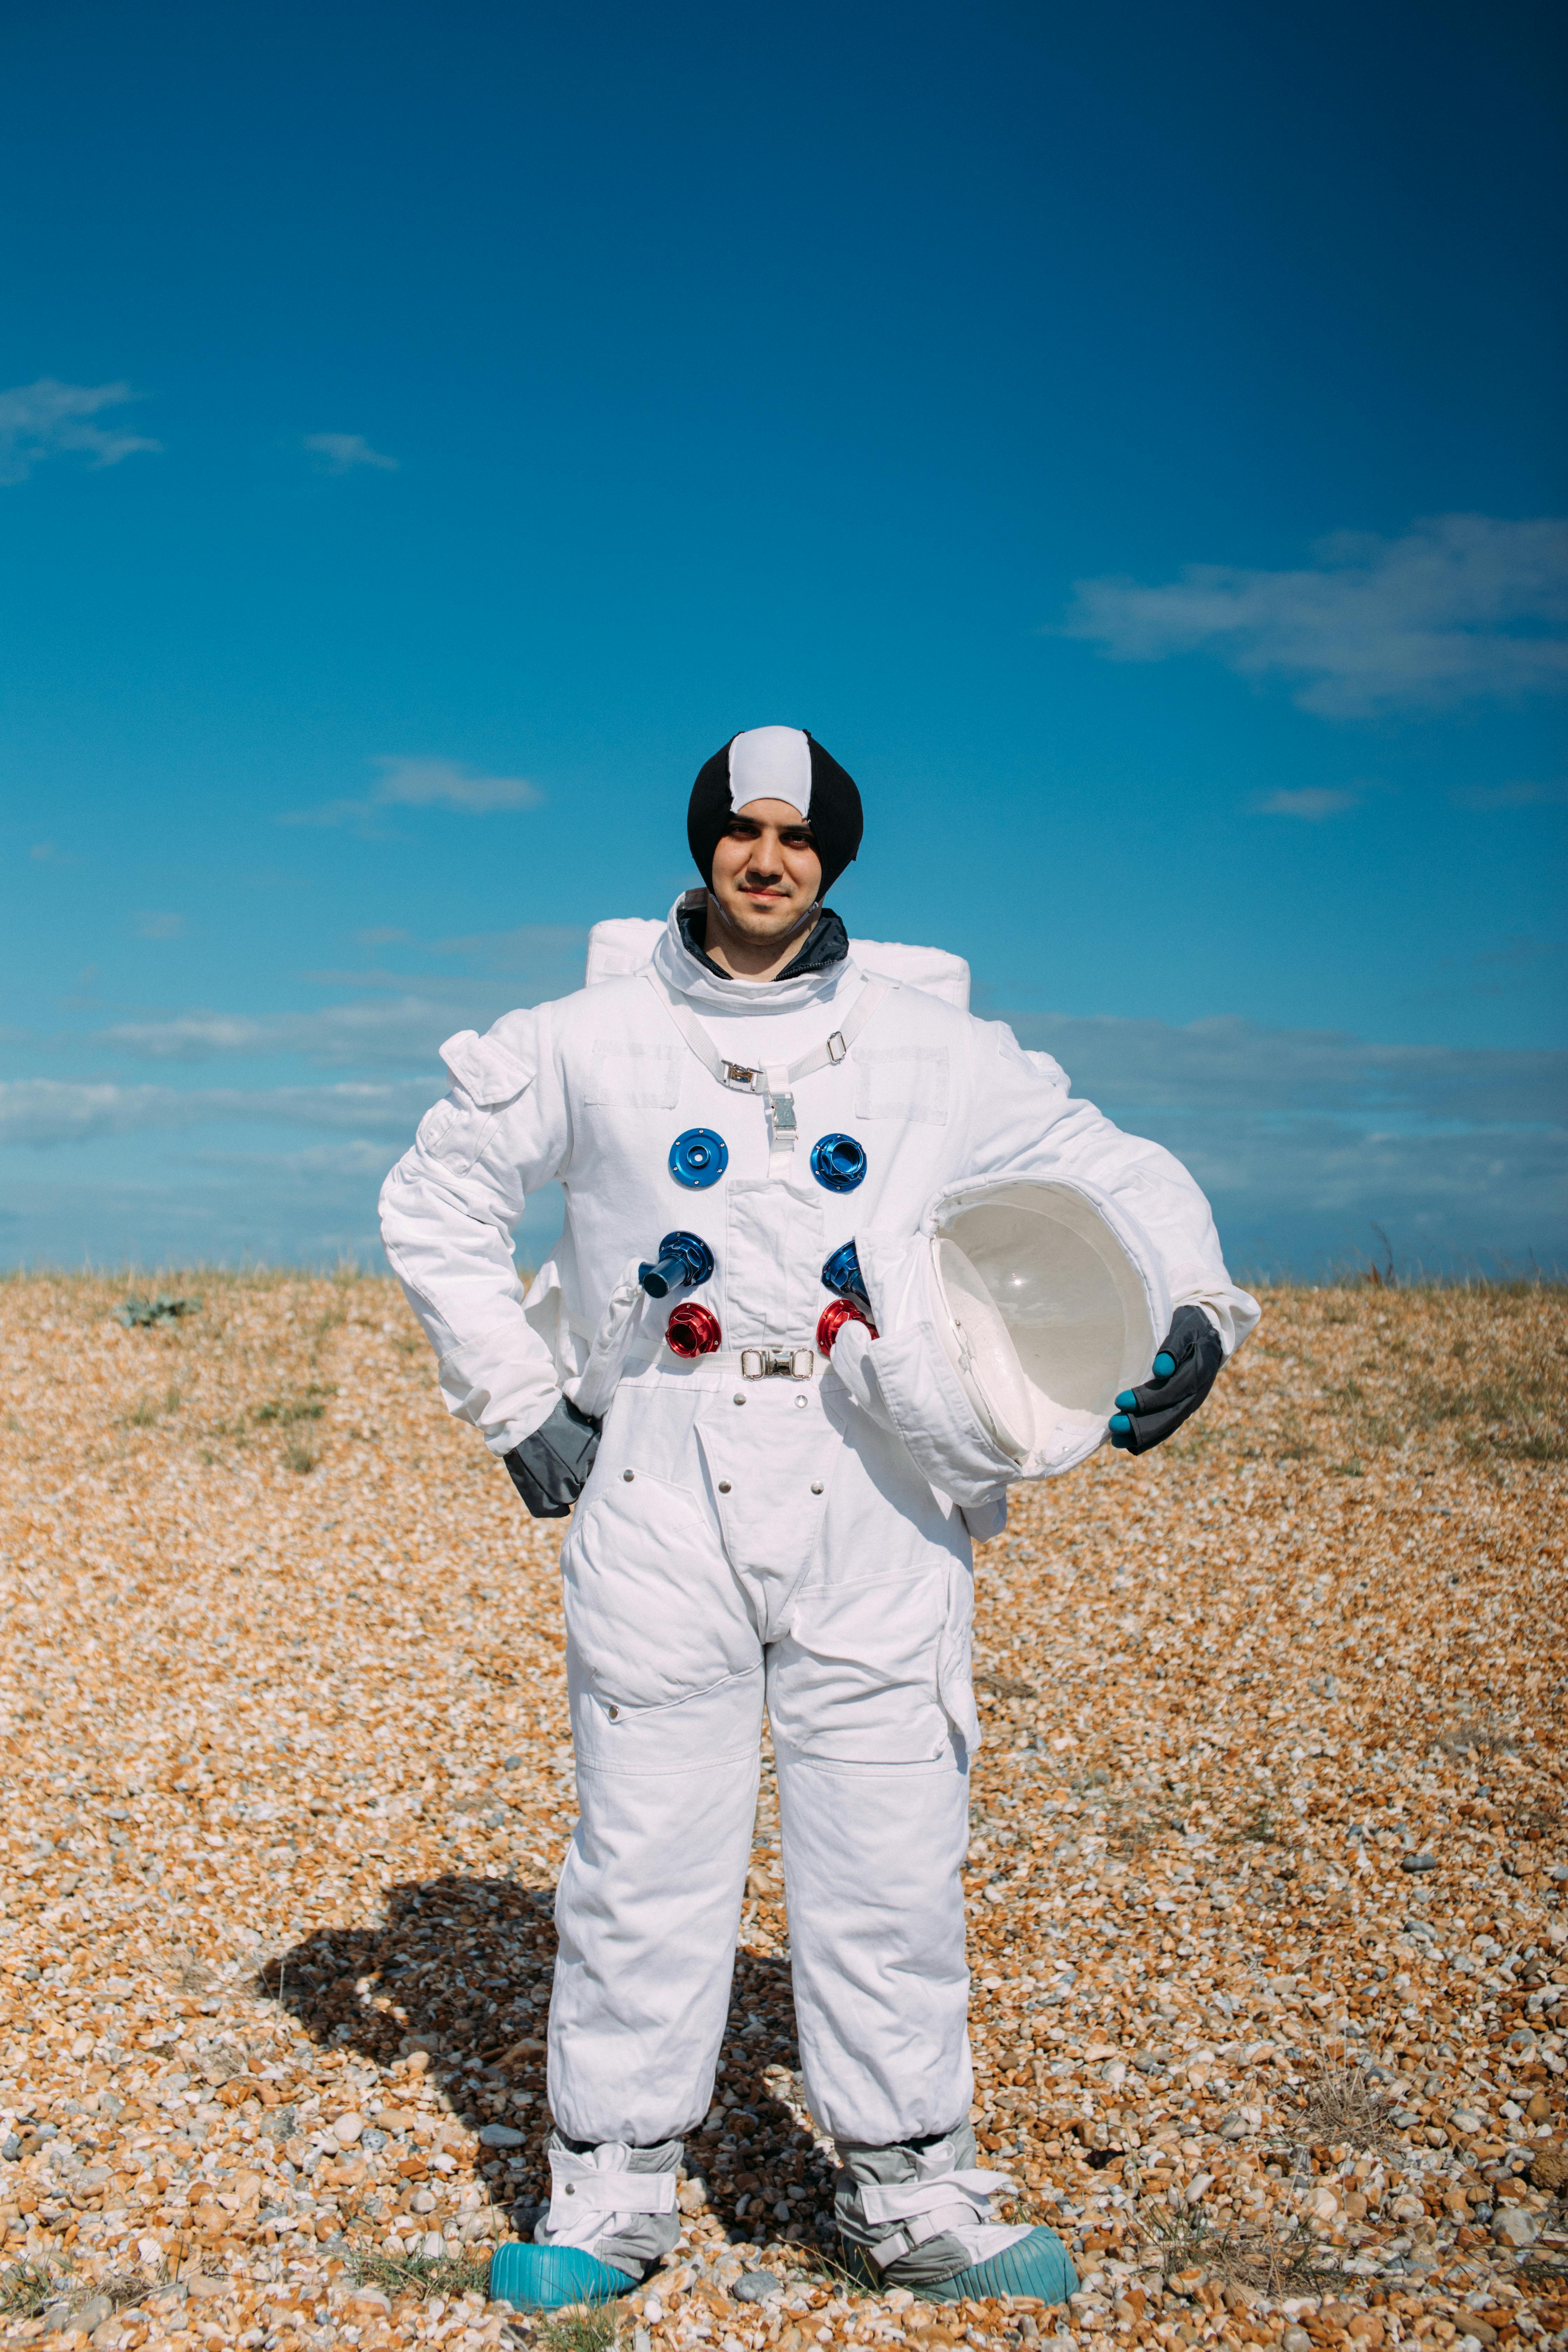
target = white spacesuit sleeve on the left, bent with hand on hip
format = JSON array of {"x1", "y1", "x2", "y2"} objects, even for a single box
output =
[{"x1": 381, "y1": 1007, "x2": 569, "y2": 1454}]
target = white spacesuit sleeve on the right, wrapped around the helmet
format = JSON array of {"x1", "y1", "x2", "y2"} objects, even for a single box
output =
[{"x1": 973, "y1": 1021, "x2": 1262, "y2": 1357}]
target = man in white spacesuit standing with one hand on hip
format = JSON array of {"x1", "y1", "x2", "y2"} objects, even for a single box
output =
[{"x1": 381, "y1": 727, "x2": 1258, "y2": 2307}]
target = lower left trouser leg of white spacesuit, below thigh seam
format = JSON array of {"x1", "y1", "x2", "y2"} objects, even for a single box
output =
[{"x1": 548, "y1": 1656, "x2": 762, "y2": 2147}]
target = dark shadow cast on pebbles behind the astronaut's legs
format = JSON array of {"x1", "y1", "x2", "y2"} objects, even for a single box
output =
[{"x1": 256, "y1": 1875, "x2": 811, "y2": 2237}]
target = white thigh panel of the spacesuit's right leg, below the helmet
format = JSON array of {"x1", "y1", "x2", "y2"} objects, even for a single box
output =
[{"x1": 769, "y1": 1571, "x2": 947, "y2": 1764}]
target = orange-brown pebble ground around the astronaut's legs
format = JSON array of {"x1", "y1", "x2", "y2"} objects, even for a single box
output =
[{"x1": 0, "y1": 1275, "x2": 1568, "y2": 2352}]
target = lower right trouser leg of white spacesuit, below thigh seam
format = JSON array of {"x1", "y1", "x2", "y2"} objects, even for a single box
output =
[{"x1": 774, "y1": 1722, "x2": 973, "y2": 2147}]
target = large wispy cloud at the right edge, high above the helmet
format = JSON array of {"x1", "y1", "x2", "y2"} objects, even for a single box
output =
[{"x1": 1060, "y1": 515, "x2": 1568, "y2": 718}]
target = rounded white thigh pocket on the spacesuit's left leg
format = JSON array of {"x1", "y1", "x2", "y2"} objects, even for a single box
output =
[{"x1": 562, "y1": 1470, "x2": 762, "y2": 1708}]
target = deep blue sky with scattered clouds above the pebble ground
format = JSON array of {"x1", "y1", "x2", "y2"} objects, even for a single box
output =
[{"x1": 0, "y1": 0, "x2": 1568, "y2": 1270}]
